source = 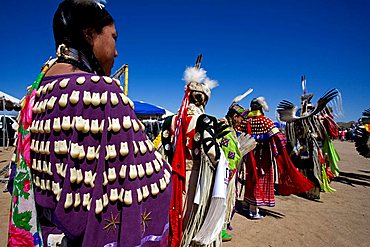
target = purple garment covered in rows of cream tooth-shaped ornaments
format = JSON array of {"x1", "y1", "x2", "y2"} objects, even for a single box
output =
[{"x1": 31, "y1": 73, "x2": 172, "y2": 247}]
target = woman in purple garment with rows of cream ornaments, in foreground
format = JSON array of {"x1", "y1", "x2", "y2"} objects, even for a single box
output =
[{"x1": 8, "y1": 0, "x2": 172, "y2": 247}]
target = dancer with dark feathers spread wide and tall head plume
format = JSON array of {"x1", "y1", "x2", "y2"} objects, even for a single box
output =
[{"x1": 277, "y1": 76, "x2": 341, "y2": 199}]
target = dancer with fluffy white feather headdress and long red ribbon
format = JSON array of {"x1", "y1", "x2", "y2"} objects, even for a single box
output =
[{"x1": 162, "y1": 57, "x2": 227, "y2": 247}]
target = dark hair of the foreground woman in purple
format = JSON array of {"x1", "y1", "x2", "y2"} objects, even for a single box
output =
[{"x1": 53, "y1": 0, "x2": 114, "y2": 73}]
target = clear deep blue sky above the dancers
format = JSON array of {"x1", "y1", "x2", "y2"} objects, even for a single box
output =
[{"x1": 0, "y1": 0, "x2": 370, "y2": 121}]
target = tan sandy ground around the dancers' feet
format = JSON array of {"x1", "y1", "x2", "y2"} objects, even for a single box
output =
[{"x1": 0, "y1": 141, "x2": 370, "y2": 247}]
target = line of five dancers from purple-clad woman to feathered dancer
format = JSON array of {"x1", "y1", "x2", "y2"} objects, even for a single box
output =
[{"x1": 8, "y1": 0, "x2": 346, "y2": 247}]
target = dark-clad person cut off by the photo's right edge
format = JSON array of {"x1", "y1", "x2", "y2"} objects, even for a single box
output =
[{"x1": 355, "y1": 108, "x2": 370, "y2": 158}]
